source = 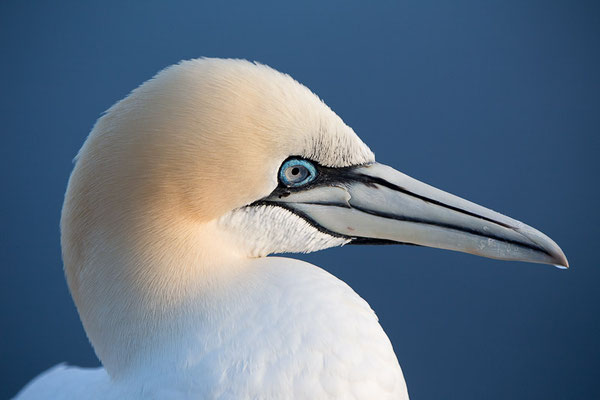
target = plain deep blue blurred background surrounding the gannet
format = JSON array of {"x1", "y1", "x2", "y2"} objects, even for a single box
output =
[{"x1": 0, "y1": 0, "x2": 600, "y2": 399}]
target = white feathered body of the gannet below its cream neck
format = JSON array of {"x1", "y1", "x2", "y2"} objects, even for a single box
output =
[{"x1": 20, "y1": 257, "x2": 407, "y2": 400}]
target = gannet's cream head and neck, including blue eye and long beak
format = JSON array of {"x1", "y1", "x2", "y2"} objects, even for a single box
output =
[{"x1": 61, "y1": 59, "x2": 568, "y2": 376}]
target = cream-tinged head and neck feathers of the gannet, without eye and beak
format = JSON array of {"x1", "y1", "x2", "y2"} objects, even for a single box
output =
[{"x1": 61, "y1": 58, "x2": 374, "y2": 371}]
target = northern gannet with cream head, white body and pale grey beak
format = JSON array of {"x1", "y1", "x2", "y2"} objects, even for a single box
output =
[{"x1": 17, "y1": 58, "x2": 568, "y2": 400}]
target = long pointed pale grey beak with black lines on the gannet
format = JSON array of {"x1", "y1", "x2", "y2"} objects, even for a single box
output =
[{"x1": 260, "y1": 163, "x2": 569, "y2": 268}]
